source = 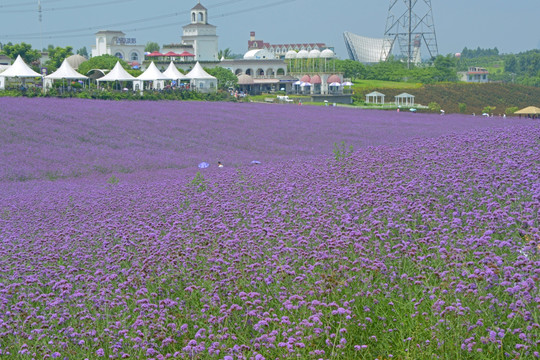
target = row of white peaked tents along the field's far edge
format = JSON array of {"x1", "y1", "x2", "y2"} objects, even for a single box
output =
[{"x1": 0, "y1": 56, "x2": 217, "y2": 92}]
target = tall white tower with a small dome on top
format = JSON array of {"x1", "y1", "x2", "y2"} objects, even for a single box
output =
[{"x1": 182, "y1": 1, "x2": 219, "y2": 61}]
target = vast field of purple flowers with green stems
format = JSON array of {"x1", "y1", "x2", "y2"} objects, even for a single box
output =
[{"x1": 0, "y1": 98, "x2": 540, "y2": 360}]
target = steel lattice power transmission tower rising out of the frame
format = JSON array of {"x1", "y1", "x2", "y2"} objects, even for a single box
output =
[{"x1": 383, "y1": 0, "x2": 439, "y2": 67}]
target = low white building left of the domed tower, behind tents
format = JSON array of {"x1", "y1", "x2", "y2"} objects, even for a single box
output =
[{"x1": 92, "y1": 30, "x2": 145, "y2": 63}]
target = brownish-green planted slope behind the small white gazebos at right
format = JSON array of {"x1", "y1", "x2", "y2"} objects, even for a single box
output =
[{"x1": 357, "y1": 83, "x2": 540, "y2": 114}]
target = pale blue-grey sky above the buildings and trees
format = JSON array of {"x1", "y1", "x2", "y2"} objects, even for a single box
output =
[{"x1": 0, "y1": 0, "x2": 540, "y2": 59}]
